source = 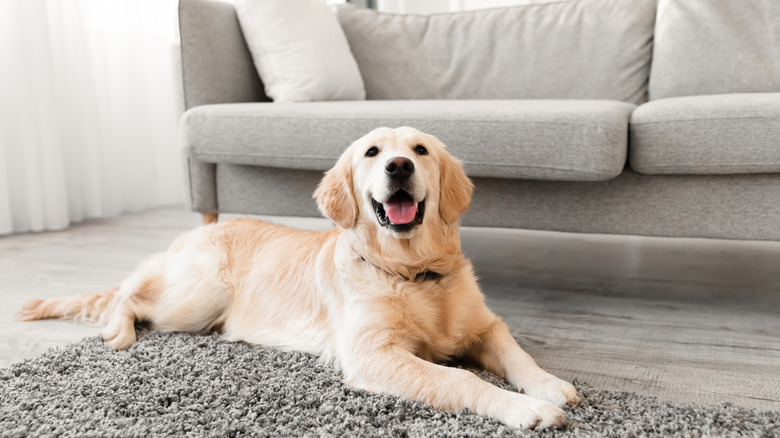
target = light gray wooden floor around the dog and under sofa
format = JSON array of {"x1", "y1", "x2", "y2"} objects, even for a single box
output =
[{"x1": 0, "y1": 208, "x2": 780, "y2": 410}]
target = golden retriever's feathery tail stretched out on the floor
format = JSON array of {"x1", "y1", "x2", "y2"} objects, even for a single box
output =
[{"x1": 16, "y1": 286, "x2": 119, "y2": 325}]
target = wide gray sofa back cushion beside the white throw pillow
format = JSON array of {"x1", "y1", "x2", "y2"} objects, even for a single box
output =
[{"x1": 338, "y1": 0, "x2": 656, "y2": 104}]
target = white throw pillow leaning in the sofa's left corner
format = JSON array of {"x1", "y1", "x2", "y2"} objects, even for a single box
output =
[{"x1": 236, "y1": 0, "x2": 366, "y2": 102}]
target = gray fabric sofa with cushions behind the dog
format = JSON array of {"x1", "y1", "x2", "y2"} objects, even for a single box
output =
[{"x1": 179, "y1": 0, "x2": 780, "y2": 240}]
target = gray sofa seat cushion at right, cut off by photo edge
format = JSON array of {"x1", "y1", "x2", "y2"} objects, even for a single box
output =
[{"x1": 629, "y1": 93, "x2": 780, "y2": 175}]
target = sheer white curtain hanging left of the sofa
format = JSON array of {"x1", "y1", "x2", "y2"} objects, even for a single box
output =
[{"x1": 0, "y1": 0, "x2": 182, "y2": 234}]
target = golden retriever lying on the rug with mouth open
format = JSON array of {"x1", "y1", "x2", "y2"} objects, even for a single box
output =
[{"x1": 17, "y1": 127, "x2": 580, "y2": 428}]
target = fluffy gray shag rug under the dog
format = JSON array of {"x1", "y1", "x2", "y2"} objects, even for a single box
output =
[{"x1": 0, "y1": 330, "x2": 780, "y2": 437}]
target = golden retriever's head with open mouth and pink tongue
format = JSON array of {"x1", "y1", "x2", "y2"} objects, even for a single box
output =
[{"x1": 314, "y1": 127, "x2": 473, "y2": 239}]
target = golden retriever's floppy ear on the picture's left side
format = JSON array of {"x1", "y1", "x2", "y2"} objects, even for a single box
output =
[{"x1": 314, "y1": 153, "x2": 358, "y2": 228}]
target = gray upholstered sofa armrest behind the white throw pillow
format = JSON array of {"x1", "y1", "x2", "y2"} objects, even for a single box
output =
[{"x1": 179, "y1": 0, "x2": 269, "y2": 109}]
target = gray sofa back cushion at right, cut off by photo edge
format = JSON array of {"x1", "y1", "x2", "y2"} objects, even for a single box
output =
[{"x1": 650, "y1": 0, "x2": 780, "y2": 100}]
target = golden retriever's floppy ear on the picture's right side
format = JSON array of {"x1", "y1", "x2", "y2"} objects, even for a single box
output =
[{"x1": 439, "y1": 149, "x2": 474, "y2": 224}]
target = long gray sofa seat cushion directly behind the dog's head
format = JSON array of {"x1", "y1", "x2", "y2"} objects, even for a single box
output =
[{"x1": 181, "y1": 100, "x2": 635, "y2": 181}]
